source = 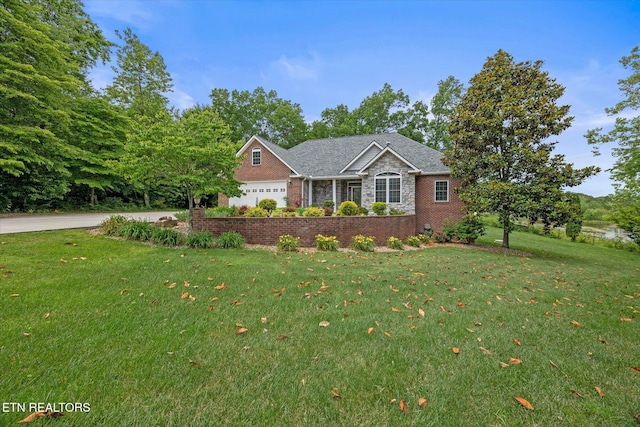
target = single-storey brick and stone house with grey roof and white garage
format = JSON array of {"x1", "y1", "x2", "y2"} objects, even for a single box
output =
[{"x1": 218, "y1": 133, "x2": 464, "y2": 232}]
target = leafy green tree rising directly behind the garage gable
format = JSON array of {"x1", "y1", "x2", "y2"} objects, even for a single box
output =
[{"x1": 209, "y1": 87, "x2": 307, "y2": 148}]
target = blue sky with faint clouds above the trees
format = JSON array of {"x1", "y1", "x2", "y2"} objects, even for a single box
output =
[{"x1": 85, "y1": 0, "x2": 640, "y2": 196}]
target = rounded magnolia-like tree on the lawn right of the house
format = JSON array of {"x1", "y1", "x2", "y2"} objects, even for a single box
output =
[{"x1": 444, "y1": 50, "x2": 598, "y2": 248}]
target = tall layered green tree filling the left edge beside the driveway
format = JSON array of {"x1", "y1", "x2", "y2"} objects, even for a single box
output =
[{"x1": 0, "y1": 0, "x2": 115, "y2": 210}]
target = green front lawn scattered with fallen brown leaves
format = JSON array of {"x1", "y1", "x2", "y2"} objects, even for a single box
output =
[{"x1": 0, "y1": 228, "x2": 640, "y2": 426}]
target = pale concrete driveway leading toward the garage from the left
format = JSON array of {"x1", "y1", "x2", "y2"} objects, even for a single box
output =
[{"x1": 0, "y1": 210, "x2": 178, "y2": 234}]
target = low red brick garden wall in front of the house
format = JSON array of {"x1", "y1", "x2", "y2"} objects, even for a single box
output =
[{"x1": 193, "y1": 209, "x2": 416, "y2": 247}]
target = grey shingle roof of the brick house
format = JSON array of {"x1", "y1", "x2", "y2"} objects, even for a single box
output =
[{"x1": 284, "y1": 133, "x2": 450, "y2": 178}]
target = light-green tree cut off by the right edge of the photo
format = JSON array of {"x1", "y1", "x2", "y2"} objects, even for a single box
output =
[{"x1": 585, "y1": 46, "x2": 640, "y2": 244}]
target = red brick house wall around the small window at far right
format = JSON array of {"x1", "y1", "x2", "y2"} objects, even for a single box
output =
[{"x1": 416, "y1": 175, "x2": 465, "y2": 236}]
